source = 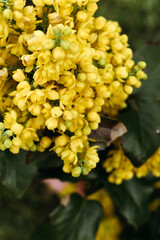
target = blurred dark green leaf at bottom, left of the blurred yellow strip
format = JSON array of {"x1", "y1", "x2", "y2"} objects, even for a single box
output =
[{"x1": 31, "y1": 194, "x2": 103, "y2": 240}]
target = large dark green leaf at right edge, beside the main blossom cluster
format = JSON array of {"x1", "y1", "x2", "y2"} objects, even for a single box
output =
[{"x1": 119, "y1": 45, "x2": 160, "y2": 166}]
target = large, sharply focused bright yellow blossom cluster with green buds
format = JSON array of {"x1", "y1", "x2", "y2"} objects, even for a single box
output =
[{"x1": 0, "y1": 0, "x2": 146, "y2": 177}]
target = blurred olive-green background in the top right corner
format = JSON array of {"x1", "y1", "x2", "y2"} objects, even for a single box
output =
[{"x1": 96, "y1": 0, "x2": 160, "y2": 50}]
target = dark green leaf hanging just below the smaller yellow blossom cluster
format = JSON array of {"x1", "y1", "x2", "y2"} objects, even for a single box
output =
[{"x1": 104, "y1": 178, "x2": 153, "y2": 228}]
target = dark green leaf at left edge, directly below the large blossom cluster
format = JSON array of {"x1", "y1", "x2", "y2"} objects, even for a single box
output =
[{"x1": 0, "y1": 150, "x2": 36, "y2": 198}]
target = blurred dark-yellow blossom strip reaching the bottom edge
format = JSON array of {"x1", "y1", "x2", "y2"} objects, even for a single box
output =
[{"x1": 88, "y1": 189, "x2": 122, "y2": 240}]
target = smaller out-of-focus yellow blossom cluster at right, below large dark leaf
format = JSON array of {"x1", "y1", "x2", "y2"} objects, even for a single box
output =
[{"x1": 103, "y1": 144, "x2": 160, "y2": 184}]
